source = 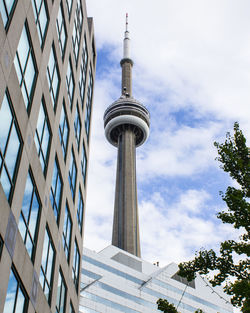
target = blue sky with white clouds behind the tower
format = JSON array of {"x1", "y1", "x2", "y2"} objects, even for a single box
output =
[{"x1": 84, "y1": 0, "x2": 250, "y2": 272}]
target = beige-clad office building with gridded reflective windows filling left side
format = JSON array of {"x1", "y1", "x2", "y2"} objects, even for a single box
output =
[{"x1": 0, "y1": 0, "x2": 96, "y2": 313}]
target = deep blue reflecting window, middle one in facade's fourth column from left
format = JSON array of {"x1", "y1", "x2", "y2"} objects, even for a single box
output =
[{"x1": 50, "y1": 158, "x2": 62, "y2": 223}]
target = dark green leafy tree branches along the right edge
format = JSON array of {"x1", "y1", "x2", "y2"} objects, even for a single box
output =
[{"x1": 178, "y1": 123, "x2": 250, "y2": 313}]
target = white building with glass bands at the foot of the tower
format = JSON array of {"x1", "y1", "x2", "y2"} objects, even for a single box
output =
[{"x1": 79, "y1": 246, "x2": 233, "y2": 313}]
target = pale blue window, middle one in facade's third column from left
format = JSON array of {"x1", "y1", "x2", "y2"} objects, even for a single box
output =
[{"x1": 35, "y1": 98, "x2": 51, "y2": 174}]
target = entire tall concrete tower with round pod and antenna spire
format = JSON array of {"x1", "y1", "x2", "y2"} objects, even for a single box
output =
[{"x1": 104, "y1": 14, "x2": 150, "y2": 257}]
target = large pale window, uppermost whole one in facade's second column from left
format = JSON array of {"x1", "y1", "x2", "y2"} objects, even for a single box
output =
[{"x1": 14, "y1": 23, "x2": 37, "y2": 111}]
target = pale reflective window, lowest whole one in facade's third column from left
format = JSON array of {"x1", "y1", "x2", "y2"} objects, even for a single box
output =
[{"x1": 39, "y1": 228, "x2": 55, "y2": 304}]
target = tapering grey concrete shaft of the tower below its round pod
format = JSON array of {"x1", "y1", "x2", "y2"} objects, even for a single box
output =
[{"x1": 112, "y1": 125, "x2": 141, "y2": 257}]
